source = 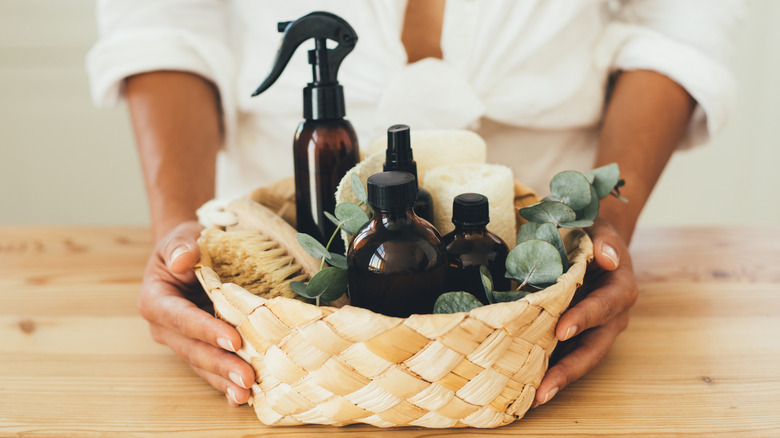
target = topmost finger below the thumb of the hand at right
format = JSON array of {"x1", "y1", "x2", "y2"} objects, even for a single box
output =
[{"x1": 555, "y1": 269, "x2": 639, "y2": 341}]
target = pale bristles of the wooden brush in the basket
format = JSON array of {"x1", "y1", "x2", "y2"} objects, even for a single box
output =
[{"x1": 202, "y1": 227, "x2": 308, "y2": 300}]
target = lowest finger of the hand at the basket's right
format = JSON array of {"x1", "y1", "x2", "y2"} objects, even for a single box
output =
[{"x1": 534, "y1": 311, "x2": 628, "y2": 406}]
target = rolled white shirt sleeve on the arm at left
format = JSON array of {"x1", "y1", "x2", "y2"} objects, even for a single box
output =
[{"x1": 86, "y1": 0, "x2": 235, "y2": 133}]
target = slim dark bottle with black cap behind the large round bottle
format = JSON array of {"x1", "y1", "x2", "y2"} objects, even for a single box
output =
[{"x1": 383, "y1": 125, "x2": 433, "y2": 223}]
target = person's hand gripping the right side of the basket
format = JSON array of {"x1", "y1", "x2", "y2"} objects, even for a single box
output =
[{"x1": 534, "y1": 218, "x2": 638, "y2": 406}]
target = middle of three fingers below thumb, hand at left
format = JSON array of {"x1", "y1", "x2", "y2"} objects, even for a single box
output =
[{"x1": 150, "y1": 325, "x2": 255, "y2": 389}]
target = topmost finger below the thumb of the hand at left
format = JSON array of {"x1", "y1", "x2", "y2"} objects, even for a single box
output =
[{"x1": 138, "y1": 281, "x2": 242, "y2": 352}]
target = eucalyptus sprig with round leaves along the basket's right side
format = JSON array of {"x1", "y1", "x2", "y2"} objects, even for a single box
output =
[{"x1": 434, "y1": 163, "x2": 628, "y2": 313}]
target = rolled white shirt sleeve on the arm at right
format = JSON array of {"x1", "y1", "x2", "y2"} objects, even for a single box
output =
[{"x1": 604, "y1": 0, "x2": 745, "y2": 148}]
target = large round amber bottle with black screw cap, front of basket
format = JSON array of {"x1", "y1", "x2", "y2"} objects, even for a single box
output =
[{"x1": 347, "y1": 172, "x2": 447, "y2": 318}]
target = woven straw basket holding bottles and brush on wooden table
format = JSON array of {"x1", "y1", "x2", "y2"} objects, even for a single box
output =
[{"x1": 196, "y1": 178, "x2": 593, "y2": 428}]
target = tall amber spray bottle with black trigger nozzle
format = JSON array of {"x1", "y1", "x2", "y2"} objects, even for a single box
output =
[{"x1": 252, "y1": 12, "x2": 360, "y2": 253}]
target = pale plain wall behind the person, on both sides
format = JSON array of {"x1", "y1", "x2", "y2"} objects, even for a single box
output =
[{"x1": 0, "y1": 0, "x2": 780, "y2": 225}]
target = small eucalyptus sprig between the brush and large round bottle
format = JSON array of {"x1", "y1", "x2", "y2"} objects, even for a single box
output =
[{"x1": 290, "y1": 173, "x2": 370, "y2": 306}]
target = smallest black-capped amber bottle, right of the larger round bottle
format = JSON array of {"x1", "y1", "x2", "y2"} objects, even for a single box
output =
[{"x1": 442, "y1": 193, "x2": 511, "y2": 304}]
